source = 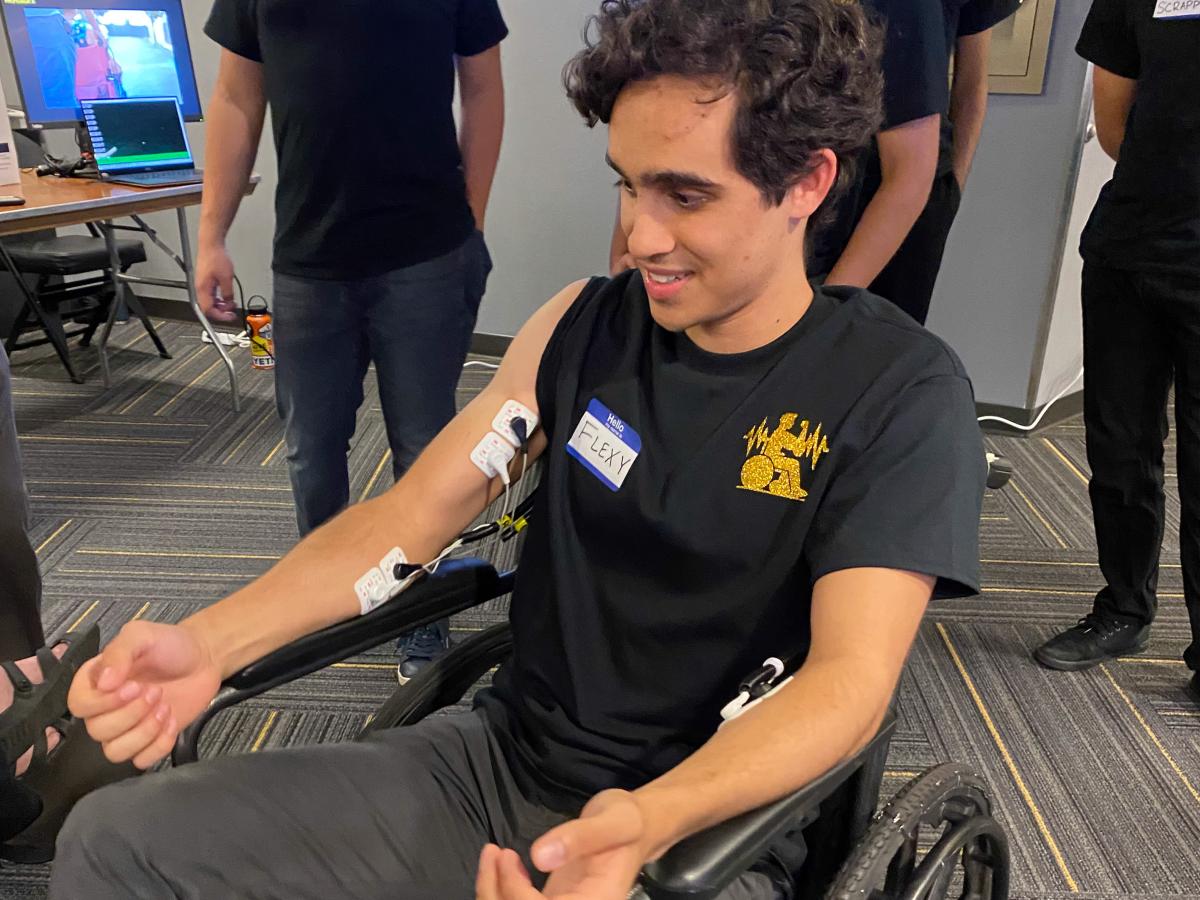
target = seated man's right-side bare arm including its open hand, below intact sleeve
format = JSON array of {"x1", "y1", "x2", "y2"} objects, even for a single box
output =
[{"x1": 492, "y1": 569, "x2": 934, "y2": 900}]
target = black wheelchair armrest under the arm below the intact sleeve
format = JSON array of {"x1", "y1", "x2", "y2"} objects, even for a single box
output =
[{"x1": 640, "y1": 712, "x2": 895, "y2": 900}]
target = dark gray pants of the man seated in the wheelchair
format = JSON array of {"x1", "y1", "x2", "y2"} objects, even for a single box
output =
[{"x1": 50, "y1": 713, "x2": 774, "y2": 900}]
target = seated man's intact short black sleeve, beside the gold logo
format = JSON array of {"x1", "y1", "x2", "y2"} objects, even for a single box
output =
[{"x1": 804, "y1": 374, "x2": 986, "y2": 598}]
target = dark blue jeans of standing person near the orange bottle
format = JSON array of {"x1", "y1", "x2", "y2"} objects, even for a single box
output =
[{"x1": 274, "y1": 232, "x2": 492, "y2": 536}]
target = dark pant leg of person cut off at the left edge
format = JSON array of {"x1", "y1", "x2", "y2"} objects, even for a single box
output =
[{"x1": 0, "y1": 348, "x2": 46, "y2": 660}]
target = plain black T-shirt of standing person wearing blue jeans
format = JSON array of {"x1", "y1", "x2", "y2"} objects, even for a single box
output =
[{"x1": 205, "y1": 0, "x2": 508, "y2": 280}]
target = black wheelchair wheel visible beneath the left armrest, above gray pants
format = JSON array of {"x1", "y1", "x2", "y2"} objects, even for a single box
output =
[{"x1": 358, "y1": 622, "x2": 512, "y2": 740}]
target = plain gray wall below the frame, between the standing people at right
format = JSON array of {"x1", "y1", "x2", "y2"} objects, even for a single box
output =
[{"x1": 929, "y1": 0, "x2": 1088, "y2": 409}]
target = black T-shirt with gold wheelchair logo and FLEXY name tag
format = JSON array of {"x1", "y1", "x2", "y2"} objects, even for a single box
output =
[{"x1": 479, "y1": 272, "x2": 984, "y2": 802}]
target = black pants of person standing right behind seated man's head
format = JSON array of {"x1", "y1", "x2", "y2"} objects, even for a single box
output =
[{"x1": 871, "y1": 172, "x2": 962, "y2": 325}]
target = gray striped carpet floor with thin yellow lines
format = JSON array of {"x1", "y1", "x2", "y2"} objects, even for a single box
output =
[{"x1": 0, "y1": 323, "x2": 1200, "y2": 900}]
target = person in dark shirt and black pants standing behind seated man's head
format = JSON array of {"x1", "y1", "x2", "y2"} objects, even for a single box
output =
[{"x1": 812, "y1": 0, "x2": 1020, "y2": 324}]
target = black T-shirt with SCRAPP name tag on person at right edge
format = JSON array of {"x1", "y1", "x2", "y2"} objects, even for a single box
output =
[{"x1": 1076, "y1": 0, "x2": 1200, "y2": 272}]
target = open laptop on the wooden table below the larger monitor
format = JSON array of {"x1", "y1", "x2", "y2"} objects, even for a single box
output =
[{"x1": 79, "y1": 97, "x2": 204, "y2": 187}]
